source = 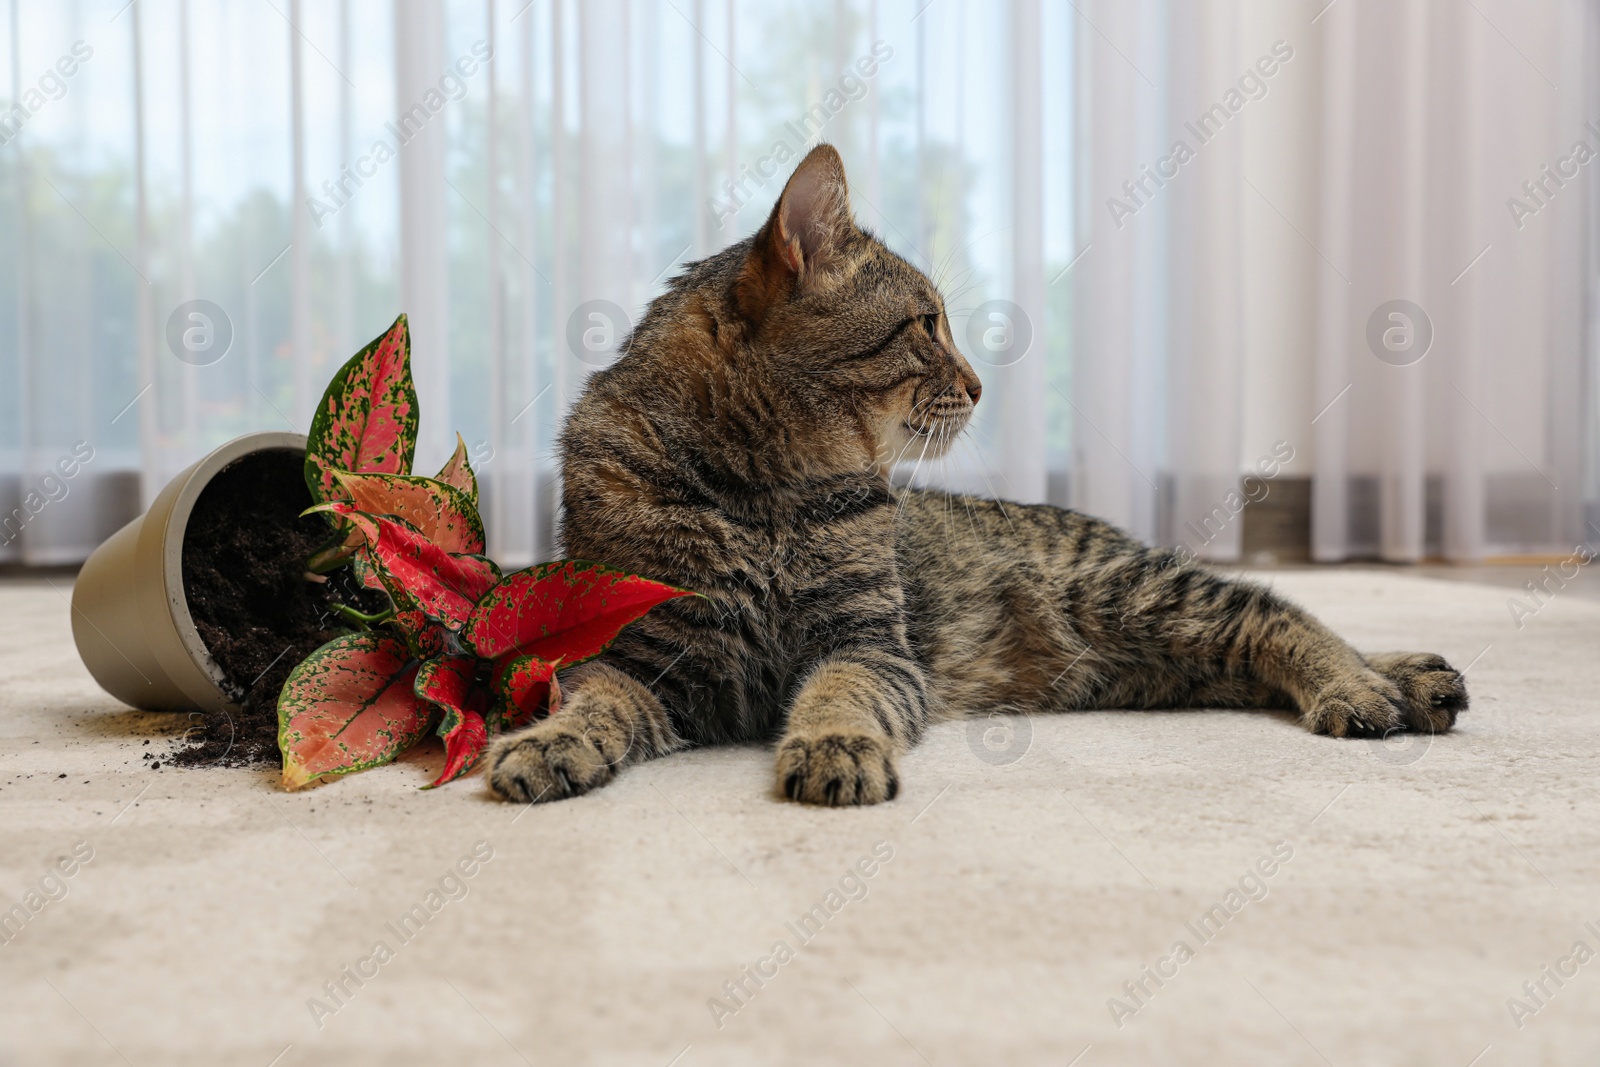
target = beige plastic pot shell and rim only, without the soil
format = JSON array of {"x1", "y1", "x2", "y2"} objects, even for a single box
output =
[{"x1": 72, "y1": 434, "x2": 306, "y2": 712}]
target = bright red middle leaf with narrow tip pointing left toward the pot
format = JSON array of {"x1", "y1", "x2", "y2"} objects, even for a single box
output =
[{"x1": 309, "y1": 501, "x2": 499, "y2": 630}]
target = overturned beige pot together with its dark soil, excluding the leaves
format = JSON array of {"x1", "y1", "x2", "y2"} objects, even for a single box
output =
[{"x1": 72, "y1": 434, "x2": 384, "y2": 763}]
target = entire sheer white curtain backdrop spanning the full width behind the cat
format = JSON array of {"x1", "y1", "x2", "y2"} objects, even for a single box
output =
[{"x1": 0, "y1": 0, "x2": 1600, "y2": 563}]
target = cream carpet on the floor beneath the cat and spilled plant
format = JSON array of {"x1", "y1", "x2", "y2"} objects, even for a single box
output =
[{"x1": 0, "y1": 568, "x2": 1600, "y2": 1067}]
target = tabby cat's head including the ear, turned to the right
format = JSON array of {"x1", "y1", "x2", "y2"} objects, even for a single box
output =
[{"x1": 738, "y1": 146, "x2": 982, "y2": 470}]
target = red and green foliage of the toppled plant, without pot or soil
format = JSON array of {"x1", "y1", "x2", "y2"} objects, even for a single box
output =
[{"x1": 277, "y1": 315, "x2": 690, "y2": 789}]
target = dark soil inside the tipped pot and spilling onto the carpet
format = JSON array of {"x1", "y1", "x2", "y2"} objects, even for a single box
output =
[{"x1": 173, "y1": 451, "x2": 387, "y2": 766}]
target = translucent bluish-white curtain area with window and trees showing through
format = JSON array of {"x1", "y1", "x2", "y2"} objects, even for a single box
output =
[{"x1": 0, "y1": 0, "x2": 1075, "y2": 563}]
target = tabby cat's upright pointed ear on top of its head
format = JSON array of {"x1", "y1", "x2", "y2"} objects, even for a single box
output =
[{"x1": 738, "y1": 144, "x2": 856, "y2": 322}]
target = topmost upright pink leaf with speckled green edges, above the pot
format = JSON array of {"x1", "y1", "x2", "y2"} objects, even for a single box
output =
[{"x1": 306, "y1": 315, "x2": 418, "y2": 502}]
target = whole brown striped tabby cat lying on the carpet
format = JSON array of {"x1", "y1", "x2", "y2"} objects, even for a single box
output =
[{"x1": 486, "y1": 146, "x2": 1467, "y2": 805}]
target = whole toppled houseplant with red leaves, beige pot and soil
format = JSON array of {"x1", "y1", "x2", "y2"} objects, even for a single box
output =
[{"x1": 72, "y1": 315, "x2": 688, "y2": 787}]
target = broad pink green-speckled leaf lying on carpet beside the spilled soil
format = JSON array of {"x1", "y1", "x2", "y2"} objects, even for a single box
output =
[{"x1": 278, "y1": 632, "x2": 434, "y2": 789}]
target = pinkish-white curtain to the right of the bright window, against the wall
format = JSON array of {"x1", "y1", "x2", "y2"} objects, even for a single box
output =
[{"x1": 1070, "y1": 0, "x2": 1600, "y2": 560}]
